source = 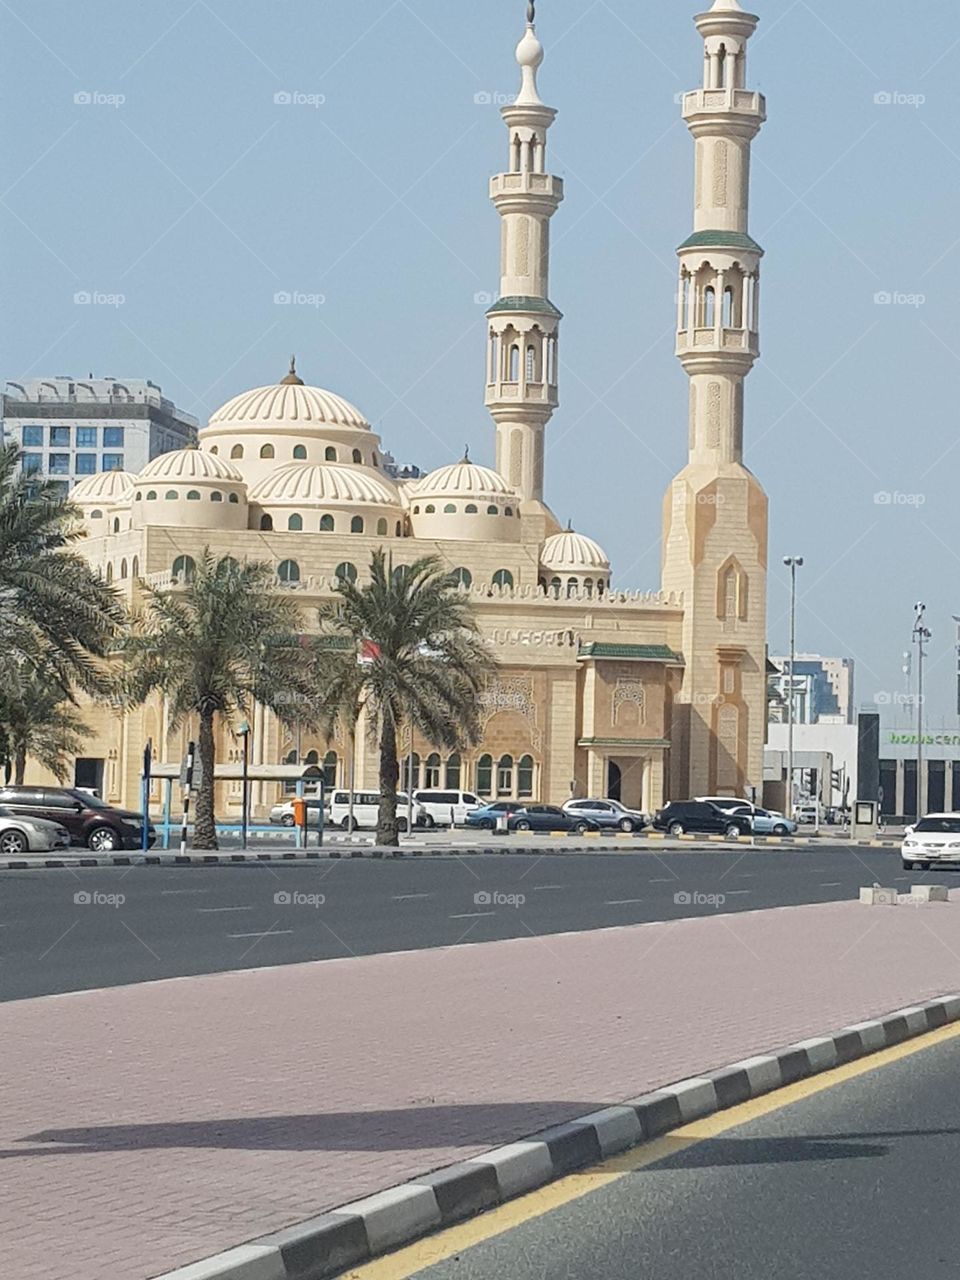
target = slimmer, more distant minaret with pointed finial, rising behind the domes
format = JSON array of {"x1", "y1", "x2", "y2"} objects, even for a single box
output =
[{"x1": 486, "y1": 3, "x2": 563, "y2": 503}]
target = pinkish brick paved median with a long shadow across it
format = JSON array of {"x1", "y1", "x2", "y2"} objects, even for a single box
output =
[{"x1": 0, "y1": 901, "x2": 960, "y2": 1280}]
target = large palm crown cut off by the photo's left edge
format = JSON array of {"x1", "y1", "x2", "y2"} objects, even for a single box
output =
[{"x1": 0, "y1": 444, "x2": 124, "y2": 696}]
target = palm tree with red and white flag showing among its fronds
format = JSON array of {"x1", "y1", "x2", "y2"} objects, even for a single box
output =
[{"x1": 320, "y1": 550, "x2": 494, "y2": 846}]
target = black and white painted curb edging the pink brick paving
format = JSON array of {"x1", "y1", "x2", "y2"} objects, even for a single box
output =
[{"x1": 156, "y1": 995, "x2": 960, "y2": 1280}]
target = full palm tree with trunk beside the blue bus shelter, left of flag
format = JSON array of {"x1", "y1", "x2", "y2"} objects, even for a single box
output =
[{"x1": 125, "y1": 548, "x2": 327, "y2": 849}]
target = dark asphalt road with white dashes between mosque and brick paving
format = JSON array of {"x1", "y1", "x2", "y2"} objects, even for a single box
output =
[{"x1": 0, "y1": 845, "x2": 916, "y2": 1000}]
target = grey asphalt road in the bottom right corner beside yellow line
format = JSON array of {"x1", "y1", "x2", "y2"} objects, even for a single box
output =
[{"x1": 391, "y1": 1038, "x2": 960, "y2": 1280}]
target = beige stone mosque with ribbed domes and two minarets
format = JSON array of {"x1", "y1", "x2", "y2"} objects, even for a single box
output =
[{"x1": 58, "y1": 0, "x2": 767, "y2": 817}]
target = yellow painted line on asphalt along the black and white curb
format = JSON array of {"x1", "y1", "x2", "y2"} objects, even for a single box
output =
[{"x1": 344, "y1": 1023, "x2": 960, "y2": 1280}]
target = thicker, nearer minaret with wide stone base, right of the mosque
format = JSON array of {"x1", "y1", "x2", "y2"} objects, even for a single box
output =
[{"x1": 663, "y1": 0, "x2": 767, "y2": 799}]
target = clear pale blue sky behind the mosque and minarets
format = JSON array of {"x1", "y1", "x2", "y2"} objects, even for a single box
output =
[{"x1": 0, "y1": 0, "x2": 960, "y2": 716}]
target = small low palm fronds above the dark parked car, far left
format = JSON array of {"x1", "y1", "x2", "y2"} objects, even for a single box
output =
[{"x1": 0, "y1": 671, "x2": 90, "y2": 786}]
